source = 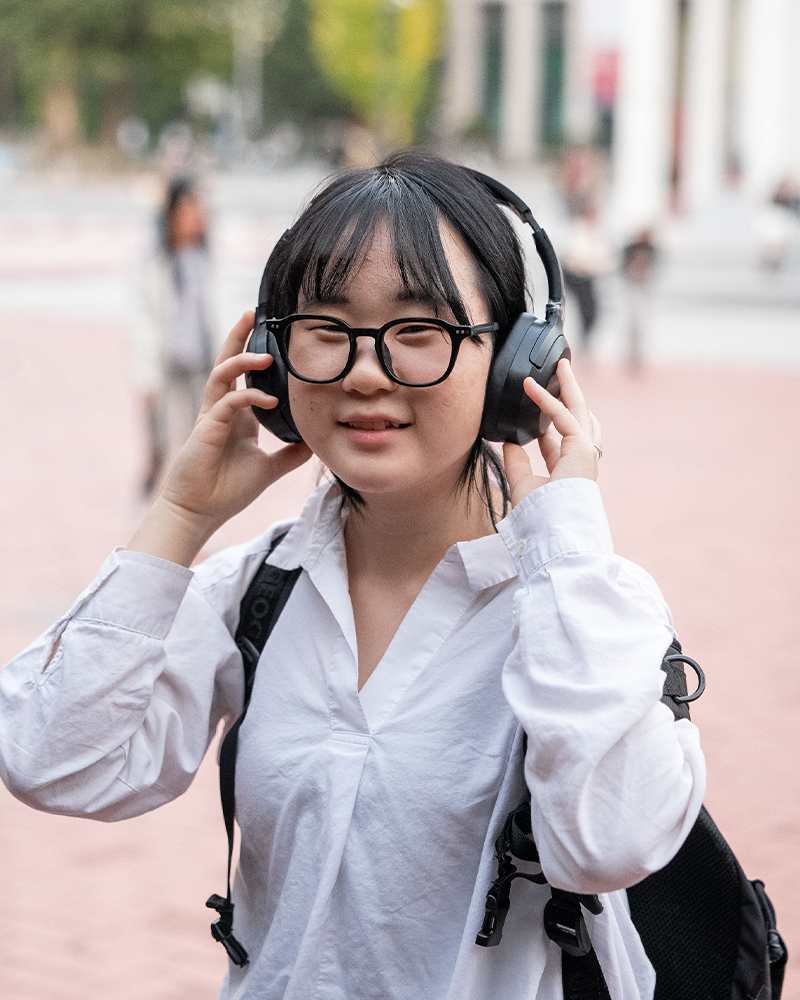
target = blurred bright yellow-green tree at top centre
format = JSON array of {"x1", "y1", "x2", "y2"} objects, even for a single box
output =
[{"x1": 309, "y1": 0, "x2": 444, "y2": 146}]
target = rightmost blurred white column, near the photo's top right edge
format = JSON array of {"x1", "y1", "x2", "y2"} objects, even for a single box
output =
[{"x1": 739, "y1": 0, "x2": 798, "y2": 200}]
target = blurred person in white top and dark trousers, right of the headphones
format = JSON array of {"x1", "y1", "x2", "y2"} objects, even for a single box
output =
[{"x1": 563, "y1": 199, "x2": 614, "y2": 353}]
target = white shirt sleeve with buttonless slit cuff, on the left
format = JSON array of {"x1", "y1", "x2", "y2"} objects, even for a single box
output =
[{"x1": 0, "y1": 551, "x2": 243, "y2": 820}]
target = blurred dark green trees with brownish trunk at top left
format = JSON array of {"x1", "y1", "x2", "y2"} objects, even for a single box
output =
[{"x1": 0, "y1": 0, "x2": 230, "y2": 145}]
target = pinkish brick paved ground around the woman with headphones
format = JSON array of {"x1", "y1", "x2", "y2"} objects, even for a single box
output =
[{"x1": 0, "y1": 168, "x2": 800, "y2": 1000}]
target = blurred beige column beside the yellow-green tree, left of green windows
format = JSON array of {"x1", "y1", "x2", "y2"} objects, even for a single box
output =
[{"x1": 442, "y1": 0, "x2": 483, "y2": 135}]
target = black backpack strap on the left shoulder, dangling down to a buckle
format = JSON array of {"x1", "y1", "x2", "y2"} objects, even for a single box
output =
[{"x1": 206, "y1": 532, "x2": 302, "y2": 966}]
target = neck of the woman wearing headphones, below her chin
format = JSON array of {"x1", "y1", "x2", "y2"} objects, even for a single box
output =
[{"x1": 345, "y1": 478, "x2": 494, "y2": 581}]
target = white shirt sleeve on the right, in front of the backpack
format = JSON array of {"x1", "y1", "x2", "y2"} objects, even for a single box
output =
[{"x1": 498, "y1": 479, "x2": 705, "y2": 893}]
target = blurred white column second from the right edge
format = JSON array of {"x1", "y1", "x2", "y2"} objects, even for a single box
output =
[{"x1": 681, "y1": 0, "x2": 728, "y2": 210}]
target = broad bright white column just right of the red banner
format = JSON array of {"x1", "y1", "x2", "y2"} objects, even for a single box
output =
[{"x1": 612, "y1": 0, "x2": 677, "y2": 235}]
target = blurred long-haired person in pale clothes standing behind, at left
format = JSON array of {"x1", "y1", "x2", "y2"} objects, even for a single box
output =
[{"x1": 133, "y1": 177, "x2": 215, "y2": 497}]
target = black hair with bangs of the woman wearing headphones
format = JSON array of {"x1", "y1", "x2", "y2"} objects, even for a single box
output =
[{"x1": 259, "y1": 152, "x2": 526, "y2": 521}]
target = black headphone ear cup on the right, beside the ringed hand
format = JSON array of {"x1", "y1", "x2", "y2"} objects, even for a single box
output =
[{"x1": 481, "y1": 313, "x2": 571, "y2": 444}]
